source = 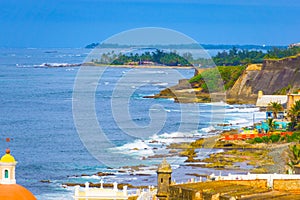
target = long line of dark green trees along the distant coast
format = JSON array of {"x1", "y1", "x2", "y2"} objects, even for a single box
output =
[{"x1": 92, "y1": 46, "x2": 300, "y2": 67}]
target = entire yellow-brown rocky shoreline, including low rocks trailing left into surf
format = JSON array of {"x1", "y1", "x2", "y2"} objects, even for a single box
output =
[{"x1": 57, "y1": 130, "x2": 291, "y2": 189}]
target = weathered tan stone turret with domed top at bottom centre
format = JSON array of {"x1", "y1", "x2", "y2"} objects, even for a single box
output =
[{"x1": 156, "y1": 158, "x2": 172, "y2": 200}]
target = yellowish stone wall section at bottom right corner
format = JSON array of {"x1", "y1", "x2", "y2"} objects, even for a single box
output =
[{"x1": 273, "y1": 179, "x2": 300, "y2": 191}]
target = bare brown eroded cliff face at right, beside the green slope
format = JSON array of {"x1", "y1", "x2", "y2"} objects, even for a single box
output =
[{"x1": 227, "y1": 55, "x2": 300, "y2": 103}]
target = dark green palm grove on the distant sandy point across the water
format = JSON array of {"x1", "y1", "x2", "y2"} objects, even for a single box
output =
[{"x1": 111, "y1": 49, "x2": 191, "y2": 66}]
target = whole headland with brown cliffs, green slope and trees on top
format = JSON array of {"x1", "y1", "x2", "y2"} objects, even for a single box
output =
[{"x1": 154, "y1": 47, "x2": 300, "y2": 104}]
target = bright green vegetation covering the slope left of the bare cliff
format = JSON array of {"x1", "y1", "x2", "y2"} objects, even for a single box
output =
[{"x1": 189, "y1": 66, "x2": 246, "y2": 92}]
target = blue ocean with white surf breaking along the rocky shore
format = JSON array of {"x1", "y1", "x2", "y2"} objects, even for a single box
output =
[{"x1": 0, "y1": 48, "x2": 264, "y2": 200}]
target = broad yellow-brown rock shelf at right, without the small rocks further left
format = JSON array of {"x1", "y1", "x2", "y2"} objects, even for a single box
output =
[{"x1": 170, "y1": 130, "x2": 291, "y2": 173}]
